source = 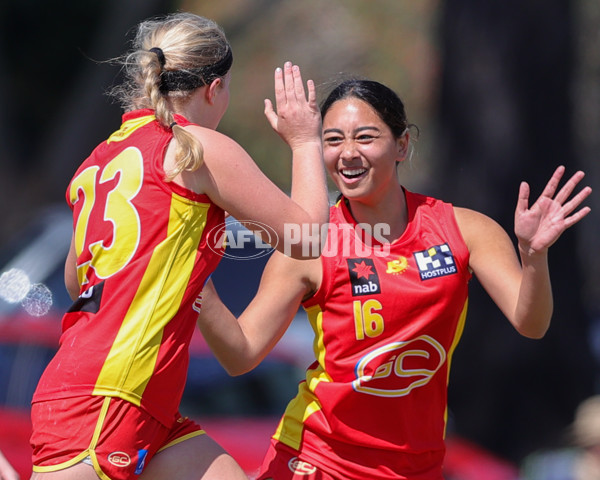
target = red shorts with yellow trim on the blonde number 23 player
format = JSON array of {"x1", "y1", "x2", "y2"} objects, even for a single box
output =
[{"x1": 31, "y1": 396, "x2": 205, "y2": 480}]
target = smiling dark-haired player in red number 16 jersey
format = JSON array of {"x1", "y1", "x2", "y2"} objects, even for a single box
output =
[{"x1": 199, "y1": 80, "x2": 591, "y2": 480}]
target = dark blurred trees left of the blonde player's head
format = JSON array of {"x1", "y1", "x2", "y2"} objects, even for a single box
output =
[{"x1": 0, "y1": 0, "x2": 176, "y2": 242}]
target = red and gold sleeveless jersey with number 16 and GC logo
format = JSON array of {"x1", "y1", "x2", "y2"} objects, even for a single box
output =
[{"x1": 274, "y1": 192, "x2": 471, "y2": 480}]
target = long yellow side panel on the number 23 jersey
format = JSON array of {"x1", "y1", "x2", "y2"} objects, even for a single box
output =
[{"x1": 92, "y1": 194, "x2": 210, "y2": 406}]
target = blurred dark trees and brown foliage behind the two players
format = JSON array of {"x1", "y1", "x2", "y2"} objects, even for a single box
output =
[{"x1": 0, "y1": 0, "x2": 600, "y2": 468}]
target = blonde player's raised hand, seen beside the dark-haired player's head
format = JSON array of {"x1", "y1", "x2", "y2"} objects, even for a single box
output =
[{"x1": 265, "y1": 62, "x2": 321, "y2": 149}]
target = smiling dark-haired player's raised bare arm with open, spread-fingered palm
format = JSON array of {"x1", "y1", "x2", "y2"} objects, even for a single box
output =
[{"x1": 455, "y1": 167, "x2": 592, "y2": 338}]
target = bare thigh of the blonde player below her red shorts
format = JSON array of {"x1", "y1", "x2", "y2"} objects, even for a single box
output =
[{"x1": 139, "y1": 435, "x2": 248, "y2": 480}]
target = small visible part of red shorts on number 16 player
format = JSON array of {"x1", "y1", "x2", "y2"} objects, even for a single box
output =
[{"x1": 256, "y1": 439, "x2": 336, "y2": 480}]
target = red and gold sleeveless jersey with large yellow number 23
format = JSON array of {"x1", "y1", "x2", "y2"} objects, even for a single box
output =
[{"x1": 33, "y1": 110, "x2": 224, "y2": 425}]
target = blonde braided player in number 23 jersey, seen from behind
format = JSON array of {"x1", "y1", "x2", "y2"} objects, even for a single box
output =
[{"x1": 31, "y1": 13, "x2": 328, "y2": 480}]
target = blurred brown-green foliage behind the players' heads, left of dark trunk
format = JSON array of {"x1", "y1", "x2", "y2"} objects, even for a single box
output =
[{"x1": 182, "y1": 0, "x2": 439, "y2": 189}]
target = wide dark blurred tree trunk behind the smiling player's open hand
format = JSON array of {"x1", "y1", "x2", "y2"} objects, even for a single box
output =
[{"x1": 437, "y1": 0, "x2": 594, "y2": 461}]
